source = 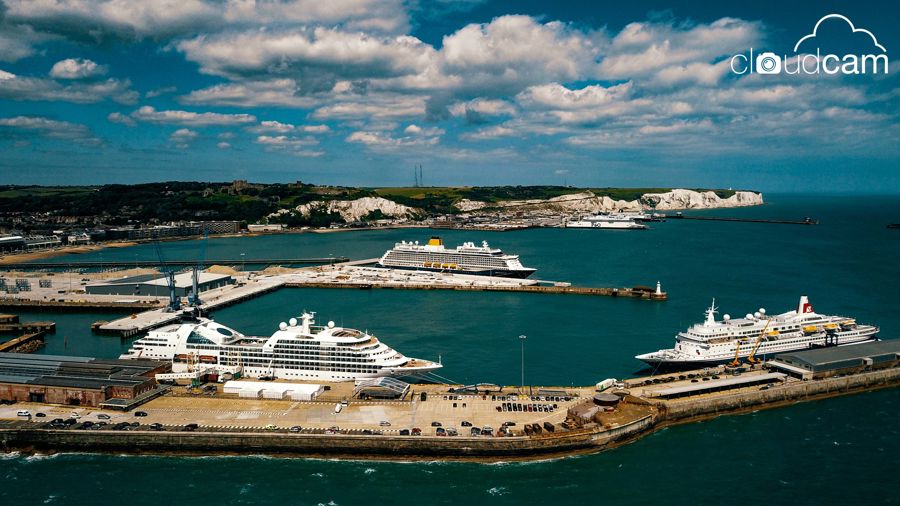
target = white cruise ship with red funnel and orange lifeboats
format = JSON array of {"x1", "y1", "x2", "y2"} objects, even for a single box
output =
[{"x1": 635, "y1": 295, "x2": 878, "y2": 369}]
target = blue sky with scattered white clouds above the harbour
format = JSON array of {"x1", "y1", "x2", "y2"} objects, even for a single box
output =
[{"x1": 0, "y1": 0, "x2": 900, "y2": 193}]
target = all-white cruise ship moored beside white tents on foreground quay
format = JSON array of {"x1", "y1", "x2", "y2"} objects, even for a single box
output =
[{"x1": 119, "y1": 312, "x2": 442, "y2": 381}]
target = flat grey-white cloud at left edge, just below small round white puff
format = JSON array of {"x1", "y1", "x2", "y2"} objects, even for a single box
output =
[{"x1": 0, "y1": 71, "x2": 138, "y2": 104}]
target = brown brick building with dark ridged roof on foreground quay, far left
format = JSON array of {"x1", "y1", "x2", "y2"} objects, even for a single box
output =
[{"x1": 0, "y1": 353, "x2": 171, "y2": 409}]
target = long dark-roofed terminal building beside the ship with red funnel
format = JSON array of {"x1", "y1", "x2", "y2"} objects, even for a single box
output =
[{"x1": 767, "y1": 339, "x2": 900, "y2": 379}]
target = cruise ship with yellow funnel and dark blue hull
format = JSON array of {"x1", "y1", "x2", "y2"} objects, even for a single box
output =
[{"x1": 376, "y1": 237, "x2": 537, "y2": 278}]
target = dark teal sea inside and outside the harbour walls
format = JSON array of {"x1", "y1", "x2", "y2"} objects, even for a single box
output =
[{"x1": 0, "y1": 194, "x2": 900, "y2": 506}]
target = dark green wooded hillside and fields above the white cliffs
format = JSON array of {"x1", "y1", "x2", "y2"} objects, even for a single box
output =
[{"x1": 0, "y1": 181, "x2": 734, "y2": 226}]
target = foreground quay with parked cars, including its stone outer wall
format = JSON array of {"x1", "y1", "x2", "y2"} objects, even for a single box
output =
[{"x1": 0, "y1": 341, "x2": 900, "y2": 461}]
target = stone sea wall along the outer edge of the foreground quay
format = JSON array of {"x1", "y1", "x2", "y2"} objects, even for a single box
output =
[{"x1": 0, "y1": 367, "x2": 900, "y2": 460}]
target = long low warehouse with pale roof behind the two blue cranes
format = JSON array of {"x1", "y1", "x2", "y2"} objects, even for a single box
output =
[{"x1": 84, "y1": 272, "x2": 234, "y2": 297}]
